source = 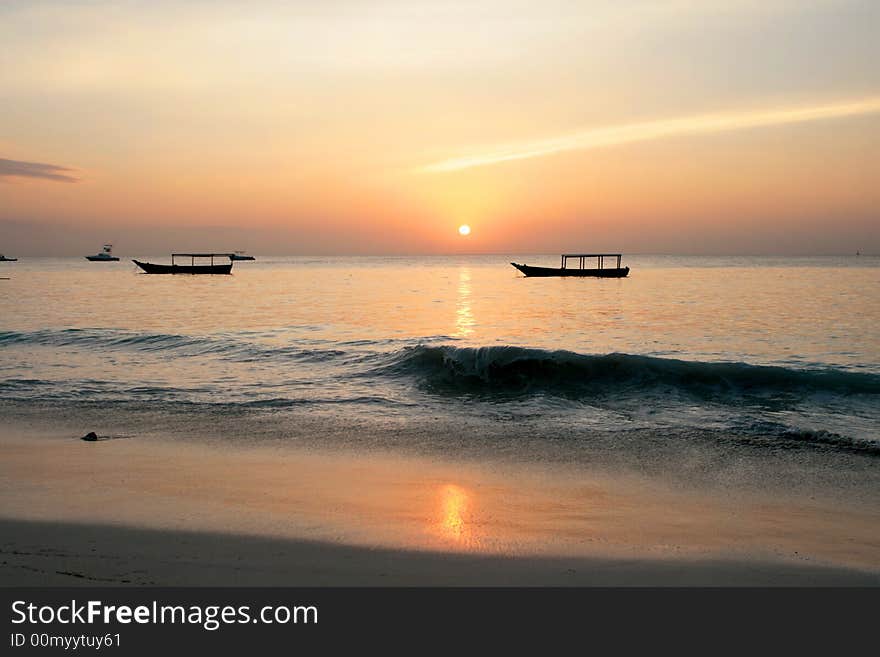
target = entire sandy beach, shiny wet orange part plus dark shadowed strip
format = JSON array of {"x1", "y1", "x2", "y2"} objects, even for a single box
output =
[{"x1": 0, "y1": 425, "x2": 880, "y2": 586}]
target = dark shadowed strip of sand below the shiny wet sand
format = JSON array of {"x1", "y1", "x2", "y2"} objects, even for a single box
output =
[{"x1": 0, "y1": 520, "x2": 880, "y2": 586}]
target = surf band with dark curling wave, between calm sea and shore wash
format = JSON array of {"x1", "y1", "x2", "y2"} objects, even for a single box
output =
[{"x1": 0, "y1": 327, "x2": 880, "y2": 455}]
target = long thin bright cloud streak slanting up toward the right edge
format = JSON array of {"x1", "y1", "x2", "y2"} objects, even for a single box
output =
[{"x1": 417, "y1": 97, "x2": 880, "y2": 173}]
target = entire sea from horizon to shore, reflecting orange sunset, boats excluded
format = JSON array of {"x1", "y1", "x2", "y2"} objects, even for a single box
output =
[{"x1": 0, "y1": 255, "x2": 880, "y2": 459}]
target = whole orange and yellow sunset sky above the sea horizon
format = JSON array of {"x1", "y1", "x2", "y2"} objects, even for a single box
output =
[{"x1": 0, "y1": 0, "x2": 880, "y2": 256}]
